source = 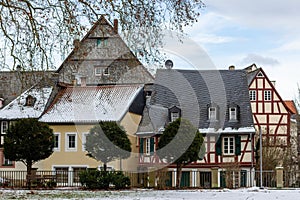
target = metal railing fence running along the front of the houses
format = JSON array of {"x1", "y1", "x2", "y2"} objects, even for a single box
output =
[{"x1": 0, "y1": 170, "x2": 300, "y2": 189}]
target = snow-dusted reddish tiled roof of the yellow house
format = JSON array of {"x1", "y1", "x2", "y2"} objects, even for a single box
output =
[{"x1": 40, "y1": 85, "x2": 143, "y2": 123}]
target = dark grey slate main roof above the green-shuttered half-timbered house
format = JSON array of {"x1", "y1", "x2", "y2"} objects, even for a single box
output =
[{"x1": 141, "y1": 69, "x2": 255, "y2": 132}]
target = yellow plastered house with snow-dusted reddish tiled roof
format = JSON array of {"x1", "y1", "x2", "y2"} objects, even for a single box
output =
[{"x1": 35, "y1": 85, "x2": 143, "y2": 171}]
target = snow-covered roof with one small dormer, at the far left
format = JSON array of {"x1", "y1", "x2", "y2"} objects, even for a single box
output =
[{"x1": 0, "y1": 87, "x2": 53, "y2": 120}]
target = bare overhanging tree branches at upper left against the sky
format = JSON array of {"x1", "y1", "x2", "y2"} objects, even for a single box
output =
[{"x1": 0, "y1": 0, "x2": 204, "y2": 70}]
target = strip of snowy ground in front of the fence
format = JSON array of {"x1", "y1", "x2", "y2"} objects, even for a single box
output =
[{"x1": 0, "y1": 188, "x2": 300, "y2": 200}]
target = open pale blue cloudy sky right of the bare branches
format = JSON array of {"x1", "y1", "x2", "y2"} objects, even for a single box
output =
[{"x1": 167, "y1": 0, "x2": 300, "y2": 100}]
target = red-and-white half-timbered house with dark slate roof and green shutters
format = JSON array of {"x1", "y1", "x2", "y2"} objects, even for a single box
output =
[{"x1": 136, "y1": 69, "x2": 255, "y2": 187}]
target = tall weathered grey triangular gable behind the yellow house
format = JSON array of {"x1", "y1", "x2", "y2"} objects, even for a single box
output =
[{"x1": 57, "y1": 16, "x2": 153, "y2": 85}]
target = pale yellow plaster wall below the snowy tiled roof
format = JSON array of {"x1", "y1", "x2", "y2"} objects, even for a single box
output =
[{"x1": 35, "y1": 113, "x2": 141, "y2": 170}]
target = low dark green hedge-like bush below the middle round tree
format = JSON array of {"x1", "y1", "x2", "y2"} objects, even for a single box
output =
[{"x1": 79, "y1": 169, "x2": 130, "y2": 189}]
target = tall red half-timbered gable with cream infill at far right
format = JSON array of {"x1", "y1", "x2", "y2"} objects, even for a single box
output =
[{"x1": 246, "y1": 64, "x2": 292, "y2": 147}]
